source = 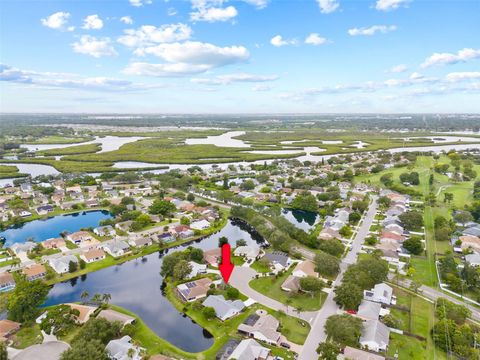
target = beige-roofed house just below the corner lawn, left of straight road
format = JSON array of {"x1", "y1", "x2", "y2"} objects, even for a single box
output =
[{"x1": 238, "y1": 310, "x2": 282, "y2": 345}]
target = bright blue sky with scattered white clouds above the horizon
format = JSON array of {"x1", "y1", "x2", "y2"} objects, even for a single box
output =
[{"x1": 0, "y1": 0, "x2": 480, "y2": 113}]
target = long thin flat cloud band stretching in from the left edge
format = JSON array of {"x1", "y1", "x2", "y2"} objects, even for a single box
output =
[{"x1": 0, "y1": 64, "x2": 161, "y2": 92}]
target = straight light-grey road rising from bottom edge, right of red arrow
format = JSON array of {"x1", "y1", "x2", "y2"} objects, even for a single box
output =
[{"x1": 298, "y1": 197, "x2": 377, "y2": 360}]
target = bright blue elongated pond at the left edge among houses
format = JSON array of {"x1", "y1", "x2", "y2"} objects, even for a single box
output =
[{"x1": 0, "y1": 210, "x2": 112, "y2": 246}]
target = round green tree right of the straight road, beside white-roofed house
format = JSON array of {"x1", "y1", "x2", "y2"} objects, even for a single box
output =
[{"x1": 325, "y1": 314, "x2": 362, "y2": 347}]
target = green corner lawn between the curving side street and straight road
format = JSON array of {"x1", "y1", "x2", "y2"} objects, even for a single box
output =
[{"x1": 250, "y1": 267, "x2": 327, "y2": 311}]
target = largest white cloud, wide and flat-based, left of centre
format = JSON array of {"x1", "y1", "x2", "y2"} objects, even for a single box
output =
[{"x1": 124, "y1": 41, "x2": 250, "y2": 76}]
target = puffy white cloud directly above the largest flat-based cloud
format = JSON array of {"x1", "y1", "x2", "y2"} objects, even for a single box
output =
[{"x1": 118, "y1": 23, "x2": 192, "y2": 48}]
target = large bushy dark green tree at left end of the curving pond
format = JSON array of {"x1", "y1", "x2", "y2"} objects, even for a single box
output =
[{"x1": 7, "y1": 279, "x2": 50, "y2": 323}]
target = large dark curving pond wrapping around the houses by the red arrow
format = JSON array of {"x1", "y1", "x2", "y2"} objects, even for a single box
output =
[{"x1": 45, "y1": 220, "x2": 262, "y2": 352}]
